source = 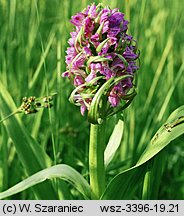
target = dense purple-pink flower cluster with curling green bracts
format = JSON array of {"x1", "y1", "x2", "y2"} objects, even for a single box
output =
[{"x1": 63, "y1": 4, "x2": 138, "y2": 114}]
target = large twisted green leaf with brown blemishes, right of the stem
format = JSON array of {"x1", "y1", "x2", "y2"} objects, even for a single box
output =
[{"x1": 101, "y1": 106, "x2": 184, "y2": 200}]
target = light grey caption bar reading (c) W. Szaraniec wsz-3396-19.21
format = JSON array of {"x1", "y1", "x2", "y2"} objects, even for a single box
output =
[{"x1": 0, "y1": 200, "x2": 184, "y2": 216}]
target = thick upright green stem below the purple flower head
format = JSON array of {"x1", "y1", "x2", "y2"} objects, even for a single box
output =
[{"x1": 89, "y1": 123, "x2": 105, "y2": 199}]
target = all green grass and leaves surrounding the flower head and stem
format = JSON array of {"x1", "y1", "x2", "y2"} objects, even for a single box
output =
[{"x1": 0, "y1": 0, "x2": 184, "y2": 199}]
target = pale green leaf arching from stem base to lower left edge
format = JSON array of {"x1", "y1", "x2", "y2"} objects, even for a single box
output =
[{"x1": 0, "y1": 164, "x2": 91, "y2": 199}]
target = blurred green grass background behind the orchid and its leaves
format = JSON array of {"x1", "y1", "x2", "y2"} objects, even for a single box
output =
[{"x1": 0, "y1": 0, "x2": 184, "y2": 199}]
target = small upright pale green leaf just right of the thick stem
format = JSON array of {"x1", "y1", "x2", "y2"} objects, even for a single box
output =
[{"x1": 104, "y1": 119, "x2": 124, "y2": 167}]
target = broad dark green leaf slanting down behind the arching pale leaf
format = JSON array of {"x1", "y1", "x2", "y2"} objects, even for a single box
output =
[{"x1": 0, "y1": 82, "x2": 58, "y2": 199}]
